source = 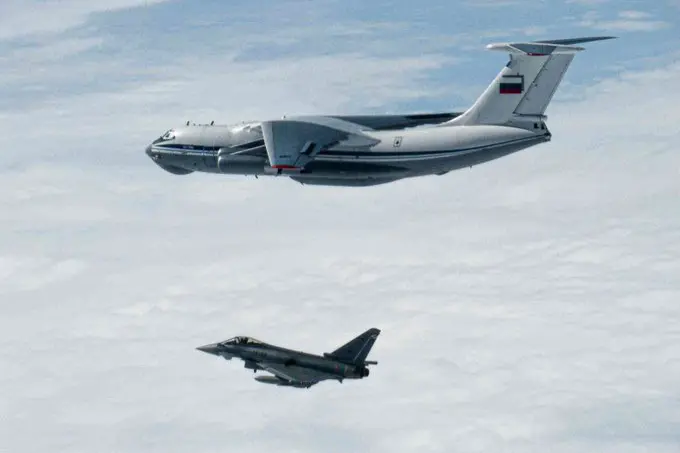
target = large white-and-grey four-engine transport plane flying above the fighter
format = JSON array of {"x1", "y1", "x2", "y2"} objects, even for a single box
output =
[{"x1": 146, "y1": 36, "x2": 612, "y2": 186}]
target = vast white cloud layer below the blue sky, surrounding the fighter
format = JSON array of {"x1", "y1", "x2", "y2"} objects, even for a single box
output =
[{"x1": 0, "y1": 1, "x2": 680, "y2": 453}]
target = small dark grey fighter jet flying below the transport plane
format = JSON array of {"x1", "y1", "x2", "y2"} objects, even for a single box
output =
[{"x1": 196, "y1": 328, "x2": 380, "y2": 388}]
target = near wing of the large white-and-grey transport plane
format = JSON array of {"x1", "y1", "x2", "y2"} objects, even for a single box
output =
[{"x1": 262, "y1": 116, "x2": 380, "y2": 170}]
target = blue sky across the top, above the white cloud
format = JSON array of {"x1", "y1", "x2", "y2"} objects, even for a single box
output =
[{"x1": 0, "y1": 1, "x2": 678, "y2": 118}]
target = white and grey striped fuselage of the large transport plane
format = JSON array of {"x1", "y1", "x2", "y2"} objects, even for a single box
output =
[{"x1": 146, "y1": 118, "x2": 550, "y2": 186}]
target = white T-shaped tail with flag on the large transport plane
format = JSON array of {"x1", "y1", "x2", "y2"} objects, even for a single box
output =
[{"x1": 445, "y1": 36, "x2": 614, "y2": 128}]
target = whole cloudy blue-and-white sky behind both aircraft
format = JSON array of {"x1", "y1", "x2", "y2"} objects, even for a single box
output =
[{"x1": 0, "y1": 0, "x2": 680, "y2": 453}]
